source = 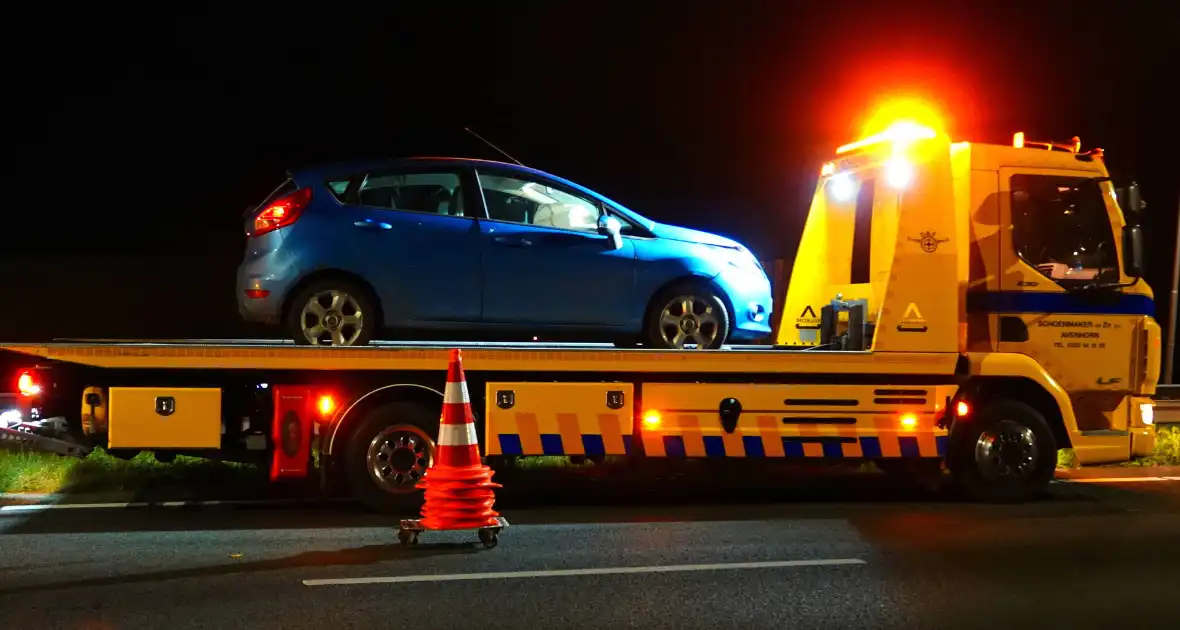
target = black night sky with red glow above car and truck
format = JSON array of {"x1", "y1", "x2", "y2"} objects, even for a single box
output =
[{"x1": 0, "y1": 1, "x2": 1180, "y2": 375}]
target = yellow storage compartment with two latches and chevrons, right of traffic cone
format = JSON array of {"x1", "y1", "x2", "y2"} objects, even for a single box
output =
[{"x1": 485, "y1": 382, "x2": 635, "y2": 455}]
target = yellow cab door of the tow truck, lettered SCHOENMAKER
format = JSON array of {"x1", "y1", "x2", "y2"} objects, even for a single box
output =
[{"x1": 988, "y1": 169, "x2": 1139, "y2": 438}]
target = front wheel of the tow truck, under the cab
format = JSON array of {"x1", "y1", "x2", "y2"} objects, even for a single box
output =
[{"x1": 949, "y1": 399, "x2": 1057, "y2": 503}]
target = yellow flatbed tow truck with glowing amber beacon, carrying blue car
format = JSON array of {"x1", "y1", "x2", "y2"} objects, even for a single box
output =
[{"x1": 4, "y1": 118, "x2": 1160, "y2": 508}]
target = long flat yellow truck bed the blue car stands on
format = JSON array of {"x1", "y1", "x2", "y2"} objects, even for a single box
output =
[{"x1": 0, "y1": 340, "x2": 958, "y2": 375}]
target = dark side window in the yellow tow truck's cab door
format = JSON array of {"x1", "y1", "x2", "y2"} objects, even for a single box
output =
[{"x1": 1010, "y1": 175, "x2": 1119, "y2": 287}]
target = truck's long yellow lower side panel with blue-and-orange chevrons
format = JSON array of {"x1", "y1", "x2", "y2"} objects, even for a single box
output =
[{"x1": 484, "y1": 382, "x2": 955, "y2": 459}]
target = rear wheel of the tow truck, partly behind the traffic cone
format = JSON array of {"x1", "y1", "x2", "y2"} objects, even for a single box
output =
[{"x1": 345, "y1": 402, "x2": 438, "y2": 512}]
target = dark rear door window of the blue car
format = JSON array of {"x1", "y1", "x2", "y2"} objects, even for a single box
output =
[{"x1": 356, "y1": 172, "x2": 465, "y2": 217}]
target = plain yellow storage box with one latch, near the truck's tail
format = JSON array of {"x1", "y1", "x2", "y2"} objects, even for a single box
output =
[{"x1": 107, "y1": 387, "x2": 222, "y2": 448}]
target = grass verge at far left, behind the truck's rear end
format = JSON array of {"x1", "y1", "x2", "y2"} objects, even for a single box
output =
[{"x1": 0, "y1": 448, "x2": 266, "y2": 494}]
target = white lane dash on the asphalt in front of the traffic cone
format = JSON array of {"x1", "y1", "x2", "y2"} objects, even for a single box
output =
[{"x1": 303, "y1": 558, "x2": 866, "y2": 586}]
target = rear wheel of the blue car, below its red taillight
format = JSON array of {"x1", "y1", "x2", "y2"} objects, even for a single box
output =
[{"x1": 287, "y1": 280, "x2": 378, "y2": 346}]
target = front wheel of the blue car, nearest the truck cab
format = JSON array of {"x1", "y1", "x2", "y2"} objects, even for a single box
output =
[{"x1": 644, "y1": 283, "x2": 729, "y2": 350}]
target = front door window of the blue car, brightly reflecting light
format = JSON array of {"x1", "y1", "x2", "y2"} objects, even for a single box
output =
[{"x1": 479, "y1": 172, "x2": 602, "y2": 231}]
